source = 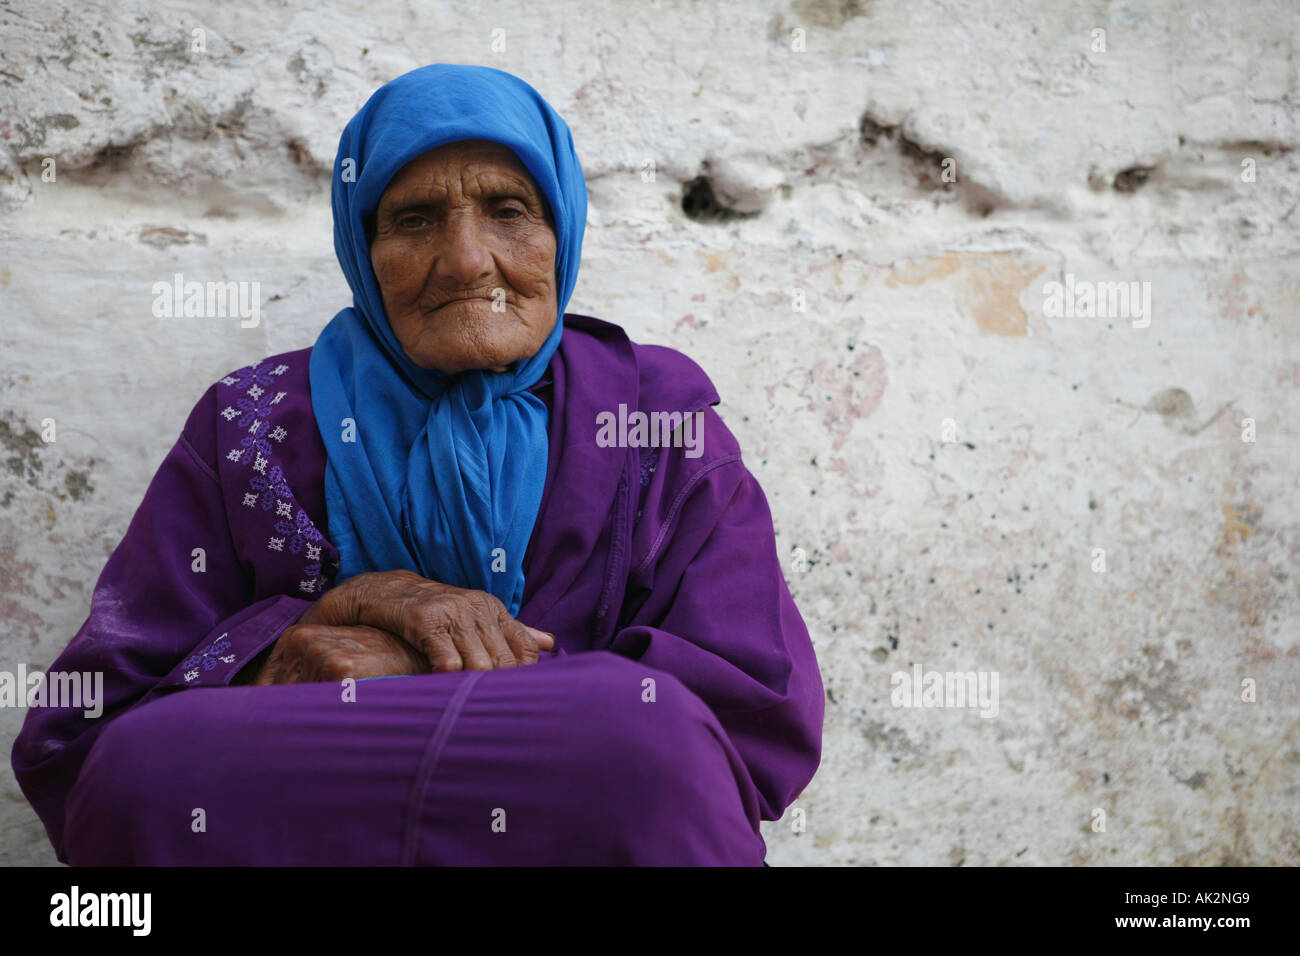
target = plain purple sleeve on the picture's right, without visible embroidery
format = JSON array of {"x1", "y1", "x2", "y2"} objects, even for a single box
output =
[{"x1": 611, "y1": 408, "x2": 826, "y2": 819}]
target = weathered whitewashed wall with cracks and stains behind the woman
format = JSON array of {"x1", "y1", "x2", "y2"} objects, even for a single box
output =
[{"x1": 0, "y1": 0, "x2": 1300, "y2": 865}]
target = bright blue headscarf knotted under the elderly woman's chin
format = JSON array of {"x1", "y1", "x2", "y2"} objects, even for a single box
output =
[{"x1": 311, "y1": 64, "x2": 586, "y2": 615}]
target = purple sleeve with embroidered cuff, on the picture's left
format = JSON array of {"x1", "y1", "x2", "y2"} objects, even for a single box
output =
[{"x1": 12, "y1": 390, "x2": 311, "y2": 862}]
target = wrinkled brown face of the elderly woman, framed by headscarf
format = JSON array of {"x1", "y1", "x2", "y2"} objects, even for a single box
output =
[{"x1": 371, "y1": 139, "x2": 556, "y2": 375}]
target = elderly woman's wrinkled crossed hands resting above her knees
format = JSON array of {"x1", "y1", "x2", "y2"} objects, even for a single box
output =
[{"x1": 254, "y1": 571, "x2": 555, "y2": 684}]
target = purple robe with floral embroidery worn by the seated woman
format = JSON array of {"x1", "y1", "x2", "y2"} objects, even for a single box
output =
[{"x1": 12, "y1": 313, "x2": 824, "y2": 865}]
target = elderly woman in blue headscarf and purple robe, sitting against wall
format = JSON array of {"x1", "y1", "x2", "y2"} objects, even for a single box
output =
[{"x1": 13, "y1": 64, "x2": 824, "y2": 865}]
